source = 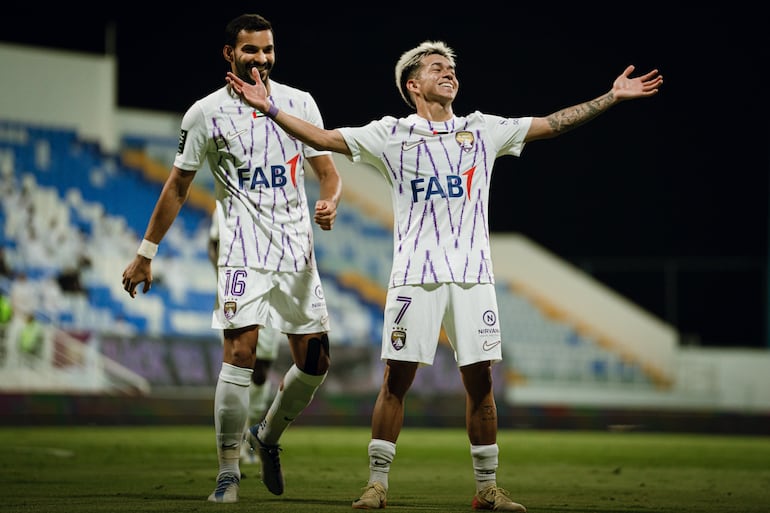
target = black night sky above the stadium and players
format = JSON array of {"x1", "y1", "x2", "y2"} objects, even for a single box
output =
[{"x1": 0, "y1": 2, "x2": 770, "y2": 347}]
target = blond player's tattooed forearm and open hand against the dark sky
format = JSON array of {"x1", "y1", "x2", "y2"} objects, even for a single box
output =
[{"x1": 525, "y1": 65, "x2": 663, "y2": 142}]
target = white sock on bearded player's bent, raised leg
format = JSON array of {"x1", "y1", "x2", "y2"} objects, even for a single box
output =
[{"x1": 259, "y1": 365, "x2": 326, "y2": 445}]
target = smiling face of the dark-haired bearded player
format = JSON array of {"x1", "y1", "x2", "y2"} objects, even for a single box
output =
[{"x1": 223, "y1": 30, "x2": 275, "y2": 86}]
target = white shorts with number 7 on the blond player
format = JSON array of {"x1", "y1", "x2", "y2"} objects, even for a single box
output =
[{"x1": 381, "y1": 283, "x2": 502, "y2": 367}]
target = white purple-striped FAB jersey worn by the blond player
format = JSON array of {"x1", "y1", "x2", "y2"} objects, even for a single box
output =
[{"x1": 340, "y1": 112, "x2": 532, "y2": 287}]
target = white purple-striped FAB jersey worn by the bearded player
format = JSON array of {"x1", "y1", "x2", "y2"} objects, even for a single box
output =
[{"x1": 174, "y1": 80, "x2": 329, "y2": 272}]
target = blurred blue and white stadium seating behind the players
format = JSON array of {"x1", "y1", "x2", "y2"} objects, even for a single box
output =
[{"x1": 0, "y1": 122, "x2": 650, "y2": 392}]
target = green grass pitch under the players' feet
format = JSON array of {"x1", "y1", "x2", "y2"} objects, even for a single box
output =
[{"x1": 0, "y1": 426, "x2": 770, "y2": 513}]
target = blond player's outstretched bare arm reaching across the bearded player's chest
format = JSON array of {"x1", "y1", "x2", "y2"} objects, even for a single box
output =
[{"x1": 225, "y1": 68, "x2": 350, "y2": 155}]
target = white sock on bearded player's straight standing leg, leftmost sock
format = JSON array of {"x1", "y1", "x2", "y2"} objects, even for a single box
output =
[{"x1": 214, "y1": 363, "x2": 252, "y2": 477}]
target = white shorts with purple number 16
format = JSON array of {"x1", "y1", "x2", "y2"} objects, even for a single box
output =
[{"x1": 211, "y1": 267, "x2": 329, "y2": 334}]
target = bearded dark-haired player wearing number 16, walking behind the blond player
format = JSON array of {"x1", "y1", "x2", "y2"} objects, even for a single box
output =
[{"x1": 123, "y1": 14, "x2": 341, "y2": 503}]
